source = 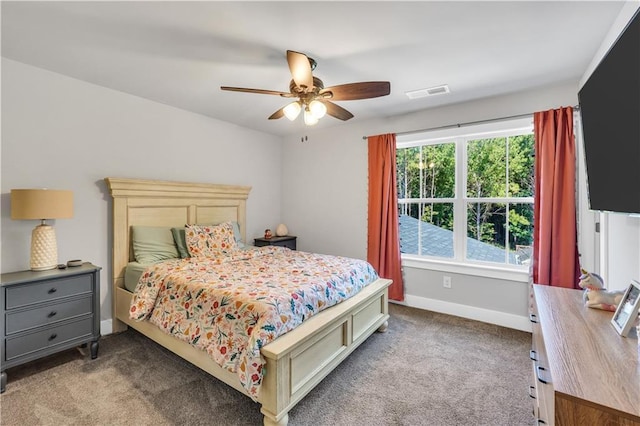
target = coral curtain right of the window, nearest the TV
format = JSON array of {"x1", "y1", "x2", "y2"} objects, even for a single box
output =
[{"x1": 533, "y1": 107, "x2": 580, "y2": 288}]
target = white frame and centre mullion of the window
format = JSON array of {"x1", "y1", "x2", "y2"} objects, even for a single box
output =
[{"x1": 396, "y1": 115, "x2": 533, "y2": 282}]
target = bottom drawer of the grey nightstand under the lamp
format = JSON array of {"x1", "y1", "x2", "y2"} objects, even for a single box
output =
[{"x1": 3, "y1": 316, "x2": 93, "y2": 361}]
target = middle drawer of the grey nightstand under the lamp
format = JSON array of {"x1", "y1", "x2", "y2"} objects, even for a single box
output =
[{"x1": 5, "y1": 295, "x2": 93, "y2": 334}]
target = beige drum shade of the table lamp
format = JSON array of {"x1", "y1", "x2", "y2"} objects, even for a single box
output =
[{"x1": 11, "y1": 189, "x2": 73, "y2": 220}]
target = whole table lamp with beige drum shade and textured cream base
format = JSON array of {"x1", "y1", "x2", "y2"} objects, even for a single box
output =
[{"x1": 11, "y1": 189, "x2": 73, "y2": 271}]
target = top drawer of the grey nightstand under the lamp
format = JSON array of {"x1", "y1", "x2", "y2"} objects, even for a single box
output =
[{"x1": 6, "y1": 274, "x2": 93, "y2": 309}]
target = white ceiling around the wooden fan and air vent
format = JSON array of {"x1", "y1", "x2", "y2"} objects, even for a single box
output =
[{"x1": 1, "y1": 1, "x2": 624, "y2": 135}]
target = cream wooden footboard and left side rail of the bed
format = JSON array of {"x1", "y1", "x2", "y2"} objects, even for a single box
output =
[{"x1": 116, "y1": 279, "x2": 391, "y2": 426}]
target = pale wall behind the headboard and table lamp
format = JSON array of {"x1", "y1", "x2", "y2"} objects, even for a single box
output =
[{"x1": 0, "y1": 58, "x2": 282, "y2": 326}]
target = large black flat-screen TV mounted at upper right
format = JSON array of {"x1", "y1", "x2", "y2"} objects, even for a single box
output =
[{"x1": 578, "y1": 11, "x2": 640, "y2": 213}]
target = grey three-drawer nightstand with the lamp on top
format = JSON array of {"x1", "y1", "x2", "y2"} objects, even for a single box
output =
[{"x1": 0, "y1": 263, "x2": 101, "y2": 393}]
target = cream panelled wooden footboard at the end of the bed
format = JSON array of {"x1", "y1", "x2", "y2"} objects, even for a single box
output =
[{"x1": 259, "y1": 279, "x2": 391, "y2": 425}]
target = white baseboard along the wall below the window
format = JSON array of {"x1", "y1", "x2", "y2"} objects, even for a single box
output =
[{"x1": 400, "y1": 294, "x2": 531, "y2": 333}]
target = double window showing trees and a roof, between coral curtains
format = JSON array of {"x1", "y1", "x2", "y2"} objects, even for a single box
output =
[{"x1": 396, "y1": 118, "x2": 534, "y2": 268}]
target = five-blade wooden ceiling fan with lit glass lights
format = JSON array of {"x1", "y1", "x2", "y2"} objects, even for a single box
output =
[{"x1": 220, "y1": 50, "x2": 391, "y2": 125}]
